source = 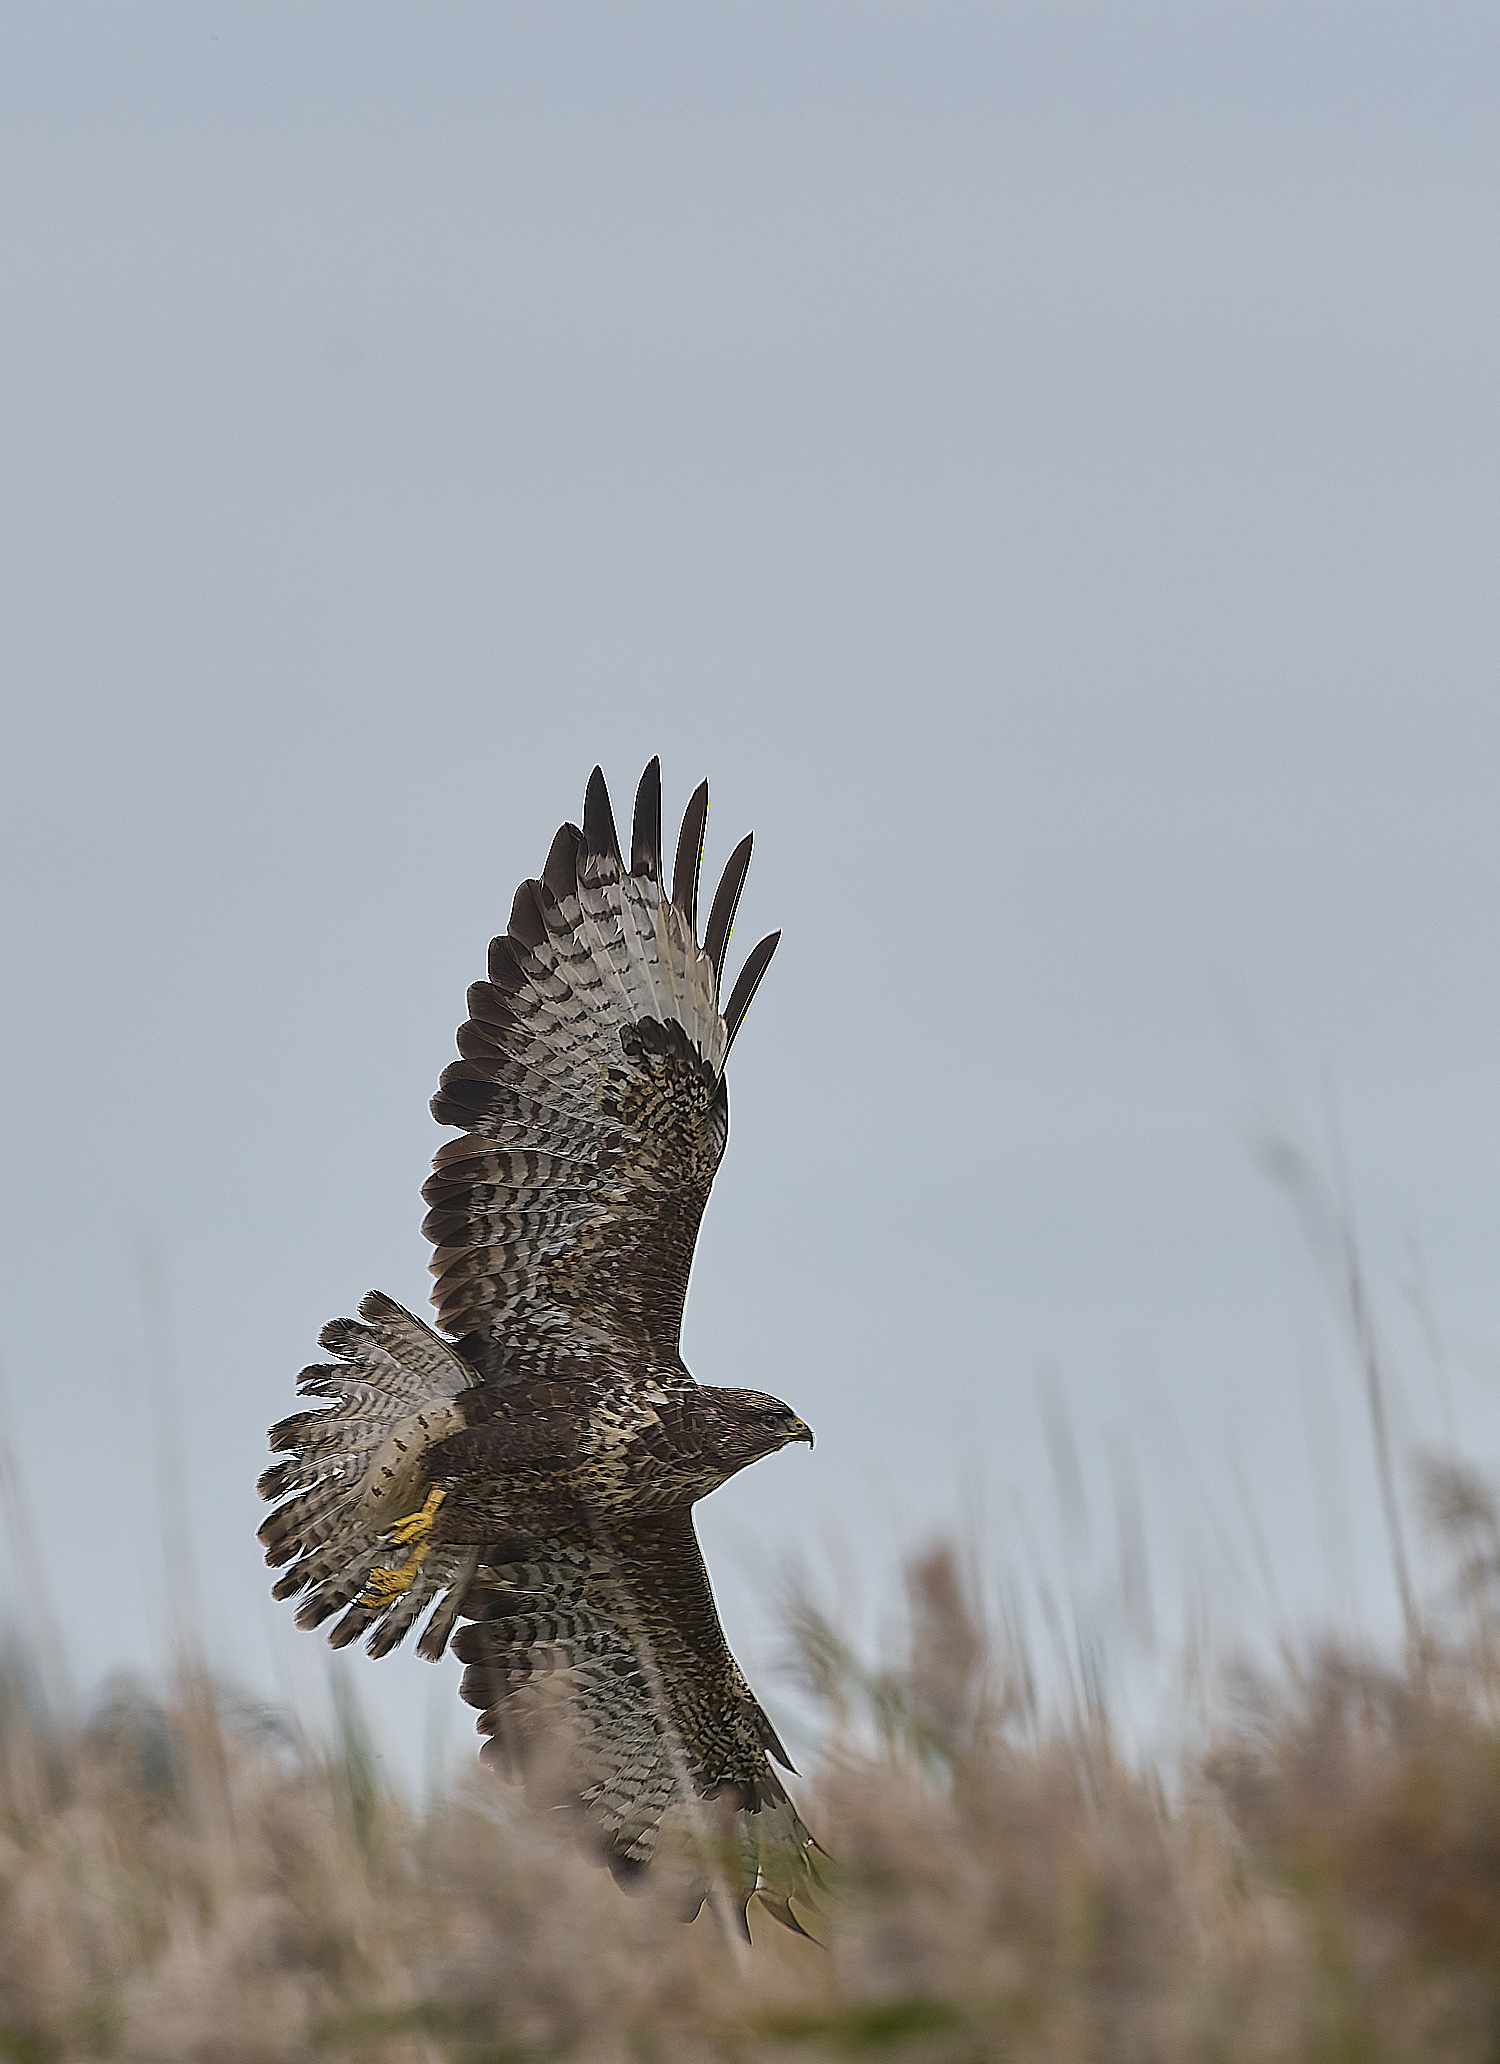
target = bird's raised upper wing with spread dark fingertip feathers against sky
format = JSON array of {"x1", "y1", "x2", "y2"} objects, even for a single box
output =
[{"x1": 423, "y1": 760, "x2": 780, "y2": 1381}]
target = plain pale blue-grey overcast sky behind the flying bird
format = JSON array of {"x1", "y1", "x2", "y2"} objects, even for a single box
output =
[{"x1": 0, "y1": 0, "x2": 1500, "y2": 1783}]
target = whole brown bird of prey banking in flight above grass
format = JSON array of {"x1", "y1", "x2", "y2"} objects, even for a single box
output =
[{"x1": 260, "y1": 760, "x2": 821, "y2": 1928}]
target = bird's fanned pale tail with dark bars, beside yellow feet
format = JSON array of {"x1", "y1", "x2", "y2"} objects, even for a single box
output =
[{"x1": 260, "y1": 1290, "x2": 479, "y2": 1657}]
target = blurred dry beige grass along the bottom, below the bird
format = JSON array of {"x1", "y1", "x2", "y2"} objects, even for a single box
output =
[{"x1": 0, "y1": 1470, "x2": 1500, "y2": 2064}]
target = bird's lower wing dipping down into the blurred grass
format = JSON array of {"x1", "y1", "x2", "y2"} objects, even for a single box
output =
[{"x1": 452, "y1": 1511, "x2": 821, "y2": 1932}]
